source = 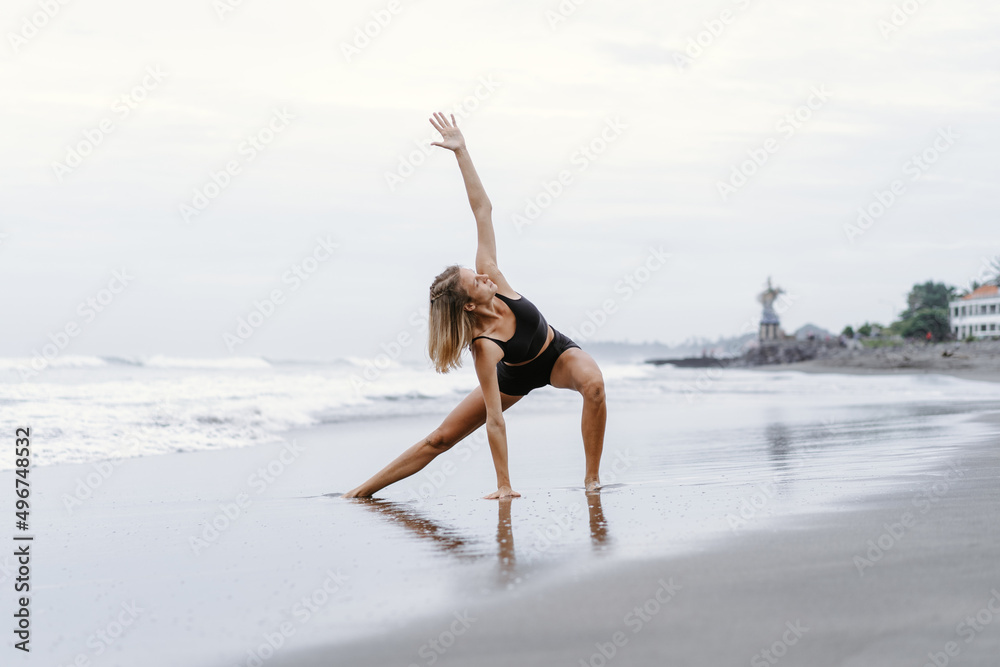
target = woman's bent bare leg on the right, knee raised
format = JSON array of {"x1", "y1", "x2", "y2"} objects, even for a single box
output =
[{"x1": 549, "y1": 347, "x2": 608, "y2": 491}]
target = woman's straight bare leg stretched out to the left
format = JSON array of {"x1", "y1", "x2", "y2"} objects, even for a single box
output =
[{"x1": 344, "y1": 387, "x2": 521, "y2": 498}]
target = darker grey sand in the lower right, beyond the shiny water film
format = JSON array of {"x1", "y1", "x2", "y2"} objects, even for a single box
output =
[{"x1": 272, "y1": 415, "x2": 1000, "y2": 667}]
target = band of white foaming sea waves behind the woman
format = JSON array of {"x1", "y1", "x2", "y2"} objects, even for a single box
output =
[{"x1": 0, "y1": 356, "x2": 1000, "y2": 470}]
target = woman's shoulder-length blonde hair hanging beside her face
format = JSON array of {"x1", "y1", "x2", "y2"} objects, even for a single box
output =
[{"x1": 427, "y1": 264, "x2": 479, "y2": 373}]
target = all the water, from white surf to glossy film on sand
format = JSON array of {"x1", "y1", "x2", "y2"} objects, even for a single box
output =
[{"x1": 11, "y1": 357, "x2": 1000, "y2": 667}]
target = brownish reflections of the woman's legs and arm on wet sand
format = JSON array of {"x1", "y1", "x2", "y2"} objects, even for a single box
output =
[{"x1": 354, "y1": 492, "x2": 611, "y2": 585}]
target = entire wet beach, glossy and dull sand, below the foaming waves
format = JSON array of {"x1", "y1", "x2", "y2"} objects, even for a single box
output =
[{"x1": 11, "y1": 369, "x2": 1000, "y2": 667}]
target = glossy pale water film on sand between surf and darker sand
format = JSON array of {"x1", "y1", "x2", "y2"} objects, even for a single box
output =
[{"x1": 13, "y1": 369, "x2": 1000, "y2": 666}]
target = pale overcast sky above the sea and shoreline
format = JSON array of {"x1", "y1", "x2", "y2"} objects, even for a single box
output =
[{"x1": 0, "y1": 0, "x2": 1000, "y2": 358}]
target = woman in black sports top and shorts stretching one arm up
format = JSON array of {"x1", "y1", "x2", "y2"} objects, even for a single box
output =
[{"x1": 344, "y1": 113, "x2": 607, "y2": 498}]
